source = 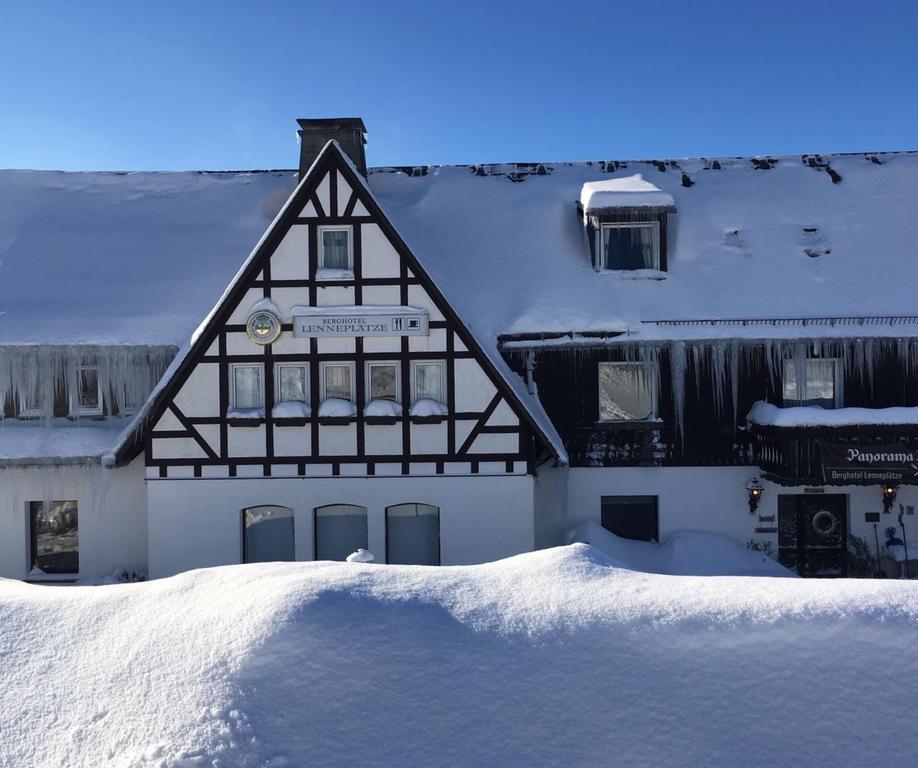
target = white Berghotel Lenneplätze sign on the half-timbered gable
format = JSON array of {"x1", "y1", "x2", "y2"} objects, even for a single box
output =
[{"x1": 293, "y1": 305, "x2": 430, "y2": 338}]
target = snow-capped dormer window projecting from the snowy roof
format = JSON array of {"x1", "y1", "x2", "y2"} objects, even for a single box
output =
[{"x1": 580, "y1": 174, "x2": 676, "y2": 272}]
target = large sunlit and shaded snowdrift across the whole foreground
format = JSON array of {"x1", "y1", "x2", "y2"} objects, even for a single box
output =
[{"x1": 0, "y1": 544, "x2": 918, "y2": 768}]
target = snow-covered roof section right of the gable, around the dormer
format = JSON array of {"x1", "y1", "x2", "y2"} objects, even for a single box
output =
[{"x1": 370, "y1": 152, "x2": 918, "y2": 341}]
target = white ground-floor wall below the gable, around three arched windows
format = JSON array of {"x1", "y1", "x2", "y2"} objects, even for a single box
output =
[{"x1": 147, "y1": 475, "x2": 534, "y2": 577}]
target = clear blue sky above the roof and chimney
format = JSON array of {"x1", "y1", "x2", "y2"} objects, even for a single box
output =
[{"x1": 0, "y1": 0, "x2": 918, "y2": 170}]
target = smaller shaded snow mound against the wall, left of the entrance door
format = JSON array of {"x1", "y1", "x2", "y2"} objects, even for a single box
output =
[{"x1": 568, "y1": 520, "x2": 796, "y2": 576}]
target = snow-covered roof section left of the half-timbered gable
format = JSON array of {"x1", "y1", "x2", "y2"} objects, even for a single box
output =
[{"x1": 0, "y1": 171, "x2": 296, "y2": 346}]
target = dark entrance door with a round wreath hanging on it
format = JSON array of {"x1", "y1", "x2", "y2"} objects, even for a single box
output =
[{"x1": 778, "y1": 493, "x2": 848, "y2": 577}]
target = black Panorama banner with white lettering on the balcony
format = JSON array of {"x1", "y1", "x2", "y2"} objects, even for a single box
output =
[{"x1": 819, "y1": 442, "x2": 918, "y2": 485}]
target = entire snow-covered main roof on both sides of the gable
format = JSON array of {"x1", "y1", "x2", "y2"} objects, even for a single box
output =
[{"x1": 0, "y1": 152, "x2": 918, "y2": 346}]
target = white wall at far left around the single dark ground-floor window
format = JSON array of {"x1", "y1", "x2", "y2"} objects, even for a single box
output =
[{"x1": 0, "y1": 457, "x2": 147, "y2": 579}]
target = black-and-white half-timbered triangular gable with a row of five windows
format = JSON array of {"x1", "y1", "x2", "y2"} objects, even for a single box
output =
[{"x1": 146, "y1": 143, "x2": 533, "y2": 478}]
